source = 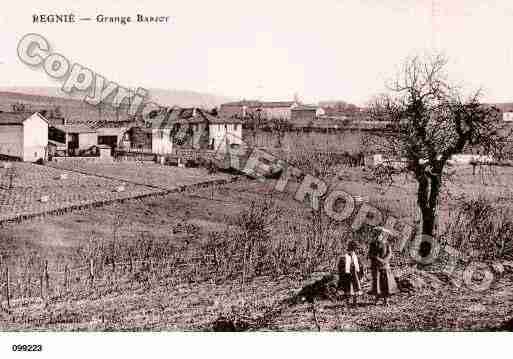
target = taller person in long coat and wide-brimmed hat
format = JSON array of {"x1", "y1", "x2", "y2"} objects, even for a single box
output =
[{"x1": 369, "y1": 236, "x2": 398, "y2": 305}]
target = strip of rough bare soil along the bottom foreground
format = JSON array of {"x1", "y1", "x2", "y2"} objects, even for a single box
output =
[{"x1": 1, "y1": 270, "x2": 513, "y2": 331}]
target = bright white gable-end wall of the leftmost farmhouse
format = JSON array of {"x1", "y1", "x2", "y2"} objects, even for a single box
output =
[{"x1": 23, "y1": 113, "x2": 48, "y2": 162}]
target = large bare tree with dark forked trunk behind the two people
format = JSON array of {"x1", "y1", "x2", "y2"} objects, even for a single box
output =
[{"x1": 370, "y1": 55, "x2": 505, "y2": 243}]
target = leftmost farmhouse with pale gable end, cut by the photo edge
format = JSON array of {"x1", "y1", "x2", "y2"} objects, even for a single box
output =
[{"x1": 0, "y1": 112, "x2": 48, "y2": 162}]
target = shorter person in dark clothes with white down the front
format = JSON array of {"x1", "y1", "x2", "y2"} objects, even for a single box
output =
[{"x1": 338, "y1": 241, "x2": 364, "y2": 306}]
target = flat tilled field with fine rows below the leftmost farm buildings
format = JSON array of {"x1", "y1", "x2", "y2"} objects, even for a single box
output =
[{"x1": 0, "y1": 161, "x2": 228, "y2": 224}]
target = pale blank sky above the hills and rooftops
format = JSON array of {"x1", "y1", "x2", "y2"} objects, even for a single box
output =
[{"x1": 0, "y1": 0, "x2": 513, "y2": 104}]
